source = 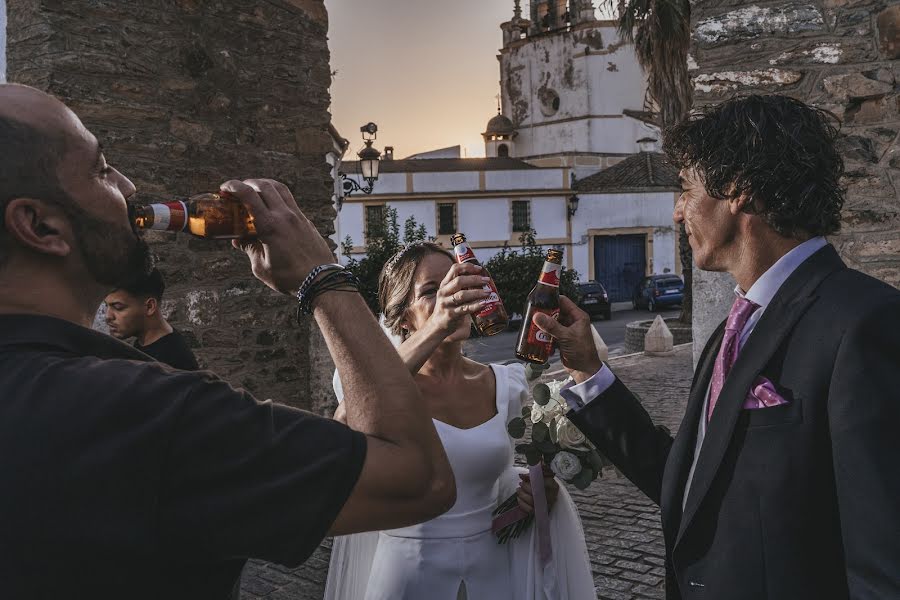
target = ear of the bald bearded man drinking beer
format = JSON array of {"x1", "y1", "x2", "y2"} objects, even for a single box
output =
[{"x1": 4, "y1": 198, "x2": 72, "y2": 257}]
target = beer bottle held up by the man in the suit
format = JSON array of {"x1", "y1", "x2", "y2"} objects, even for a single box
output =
[{"x1": 516, "y1": 250, "x2": 562, "y2": 365}]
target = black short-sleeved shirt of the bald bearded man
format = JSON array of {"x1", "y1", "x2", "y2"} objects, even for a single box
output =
[{"x1": 0, "y1": 315, "x2": 366, "y2": 599}]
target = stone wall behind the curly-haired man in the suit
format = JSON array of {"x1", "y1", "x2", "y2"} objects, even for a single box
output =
[{"x1": 690, "y1": 0, "x2": 900, "y2": 358}]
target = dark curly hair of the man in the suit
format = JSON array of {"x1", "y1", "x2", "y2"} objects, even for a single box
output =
[{"x1": 664, "y1": 95, "x2": 844, "y2": 238}]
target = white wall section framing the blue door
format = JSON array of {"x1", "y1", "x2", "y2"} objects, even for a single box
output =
[{"x1": 571, "y1": 192, "x2": 677, "y2": 280}]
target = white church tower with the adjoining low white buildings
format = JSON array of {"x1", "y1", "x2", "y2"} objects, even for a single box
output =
[{"x1": 336, "y1": 0, "x2": 680, "y2": 301}]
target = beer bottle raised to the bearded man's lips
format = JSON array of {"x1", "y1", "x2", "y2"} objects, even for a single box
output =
[{"x1": 129, "y1": 193, "x2": 256, "y2": 240}]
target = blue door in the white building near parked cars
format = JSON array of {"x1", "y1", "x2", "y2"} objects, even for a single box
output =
[{"x1": 594, "y1": 234, "x2": 647, "y2": 302}]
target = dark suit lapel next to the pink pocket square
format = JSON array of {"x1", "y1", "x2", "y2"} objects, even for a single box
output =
[{"x1": 675, "y1": 245, "x2": 845, "y2": 545}]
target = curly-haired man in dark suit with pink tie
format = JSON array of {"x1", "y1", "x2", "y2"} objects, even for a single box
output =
[{"x1": 535, "y1": 96, "x2": 900, "y2": 600}]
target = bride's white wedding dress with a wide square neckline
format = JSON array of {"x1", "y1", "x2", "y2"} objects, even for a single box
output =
[{"x1": 325, "y1": 356, "x2": 597, "y2": 600}]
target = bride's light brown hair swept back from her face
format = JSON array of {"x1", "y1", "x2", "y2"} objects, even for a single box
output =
[{"x1": 378, "y1": 242, "x2": 456, "y2": 339}]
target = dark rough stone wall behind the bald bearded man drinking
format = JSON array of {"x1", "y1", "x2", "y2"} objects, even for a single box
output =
[{"x1": 7, "y1": 0, "x2": 335, "y2": 408}]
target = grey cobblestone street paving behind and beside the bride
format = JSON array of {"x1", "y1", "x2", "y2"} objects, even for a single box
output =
[{"x1": 241, "y1": 344, "x2": 692, "y2": 600}]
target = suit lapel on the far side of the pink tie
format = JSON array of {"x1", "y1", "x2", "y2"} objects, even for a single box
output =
[{"x1": 660, "y1": 321, "x2": 725, "y2": 540}]
